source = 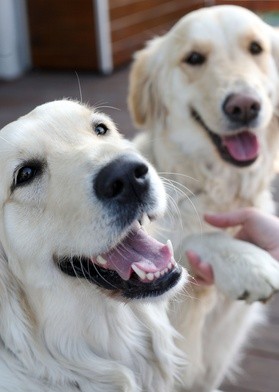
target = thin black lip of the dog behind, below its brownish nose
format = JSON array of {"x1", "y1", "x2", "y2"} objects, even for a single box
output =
[{"x1": 190, "y1": 107, "x2": 257, "y2": 167}]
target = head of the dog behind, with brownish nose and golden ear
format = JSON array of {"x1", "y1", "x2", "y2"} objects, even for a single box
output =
[{"x1": 129, "y1": 6, "x2": 279, "y2": 167}]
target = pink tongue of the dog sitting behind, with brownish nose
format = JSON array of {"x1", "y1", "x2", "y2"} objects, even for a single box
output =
[{"x1": 223, "y1": 131, "x2": 259, "y2": 161}]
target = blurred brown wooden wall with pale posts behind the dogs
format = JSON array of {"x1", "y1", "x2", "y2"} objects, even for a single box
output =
[{"x1": 0, "y1": 0, "x2": 278, "y2": 78}]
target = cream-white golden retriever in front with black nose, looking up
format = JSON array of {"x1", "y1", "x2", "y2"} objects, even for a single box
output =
[{"x1": 0, "y1": 100, "x2": 187, "y2": 392}]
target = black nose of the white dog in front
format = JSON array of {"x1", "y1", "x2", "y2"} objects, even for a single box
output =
[{"x1": 94, "y1": 154, "x2": 150, "y2": 202}]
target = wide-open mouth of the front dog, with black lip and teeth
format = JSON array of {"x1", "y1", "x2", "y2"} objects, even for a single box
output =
[{"x1": 55, "y1": 222, "x2": 182, "y2": 298}]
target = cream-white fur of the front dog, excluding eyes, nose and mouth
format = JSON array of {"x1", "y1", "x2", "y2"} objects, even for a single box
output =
[{"x1": 0, "y1": 100, "x2": 187, "y2": 392}]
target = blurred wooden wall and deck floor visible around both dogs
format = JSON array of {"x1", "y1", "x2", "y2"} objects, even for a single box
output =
[{"x1": 0, "y1": 0, "x2": 279, "y2": 392}]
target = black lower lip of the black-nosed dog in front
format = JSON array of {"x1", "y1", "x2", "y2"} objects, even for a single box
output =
[{"x1": 55, "y1": 257, "x2": 182, "y2": 299}]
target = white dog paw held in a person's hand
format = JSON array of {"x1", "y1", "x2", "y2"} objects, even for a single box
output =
[{"x1": 186, "y1": 233, "x2": 279, "y2": 303}]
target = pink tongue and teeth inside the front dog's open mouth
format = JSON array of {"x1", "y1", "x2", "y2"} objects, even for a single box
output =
[{"x1": 93, "y1": 227, "x2": 174, "y2": 280}]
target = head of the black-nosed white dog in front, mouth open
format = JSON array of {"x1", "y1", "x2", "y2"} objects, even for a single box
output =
[{"x1": 0, "y1": 100, "x2": 184, "y2": 298}]
